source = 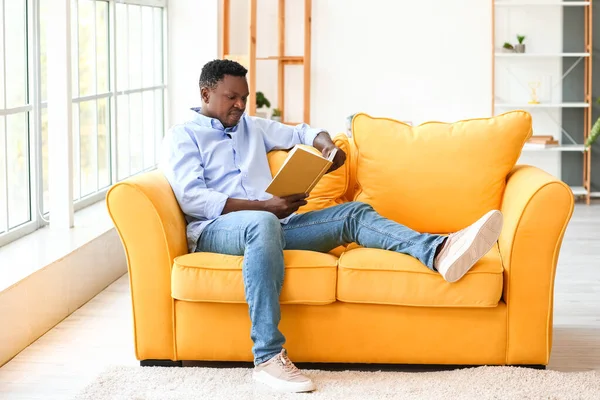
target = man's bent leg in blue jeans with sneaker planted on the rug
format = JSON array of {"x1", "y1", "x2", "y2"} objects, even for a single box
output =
[{"x1": 196, "y1": 211, "x2": 315, "y2": 392}]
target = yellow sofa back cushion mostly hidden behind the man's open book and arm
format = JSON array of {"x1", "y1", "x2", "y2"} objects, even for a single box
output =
[{"x1": 268, "y1": 134, "x2": 351, "y2": 213}]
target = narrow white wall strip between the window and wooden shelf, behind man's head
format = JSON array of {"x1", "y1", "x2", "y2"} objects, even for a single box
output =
[{"x1": 167, "y1": 0, "x2": 220, "y2": 126}]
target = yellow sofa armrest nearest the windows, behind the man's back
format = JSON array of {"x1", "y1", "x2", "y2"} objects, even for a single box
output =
[{"x1": 106, "y1": 171, "x2": 187, "y2": 360}]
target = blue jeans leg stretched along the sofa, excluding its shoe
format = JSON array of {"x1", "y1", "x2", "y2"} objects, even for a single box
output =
[{"x1": 283, "y1": 202, "x2": 446, "y2": 270}]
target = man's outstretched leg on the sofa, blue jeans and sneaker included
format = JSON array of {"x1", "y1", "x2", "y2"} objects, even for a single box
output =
[{"x1": 284, "y1": 202, "x2": 502, "y2": 282}]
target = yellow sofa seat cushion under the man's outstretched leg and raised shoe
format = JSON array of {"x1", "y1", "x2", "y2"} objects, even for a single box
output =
[{"x1": 337, "y1": 246, "x2": 503, "y2": 307}]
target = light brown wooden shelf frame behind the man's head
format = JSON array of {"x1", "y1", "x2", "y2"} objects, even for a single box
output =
[{"x1": 221, "y1": 0, "x2": 312, "y2": 124}]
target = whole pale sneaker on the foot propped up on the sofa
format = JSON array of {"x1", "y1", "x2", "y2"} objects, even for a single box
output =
[{"x1": 433, "y1": 210, "x2": 503, "y2": 282}]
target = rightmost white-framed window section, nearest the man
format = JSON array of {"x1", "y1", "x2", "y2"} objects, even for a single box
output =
[{"x1": 116, "y1": 4, "x2": 165, "y2": 180}]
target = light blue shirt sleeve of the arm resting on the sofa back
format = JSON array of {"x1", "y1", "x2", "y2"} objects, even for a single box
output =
[{"x1": 253, "y1": 118, "x2": 327, "y2": 152}]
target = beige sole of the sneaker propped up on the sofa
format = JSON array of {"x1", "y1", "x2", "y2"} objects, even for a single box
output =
[{"x1": 444, "y1": 210, "x2": 503, "y2": 283}]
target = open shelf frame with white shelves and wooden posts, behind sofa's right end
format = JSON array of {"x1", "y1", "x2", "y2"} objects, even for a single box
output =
[{"x1": 491, "y1": 0, "x2": 593, "y2": 205}]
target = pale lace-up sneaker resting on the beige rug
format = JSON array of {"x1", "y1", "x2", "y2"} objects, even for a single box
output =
[{"x1": 252, "y1": 349, "x2": 315, "y2": 393}]
